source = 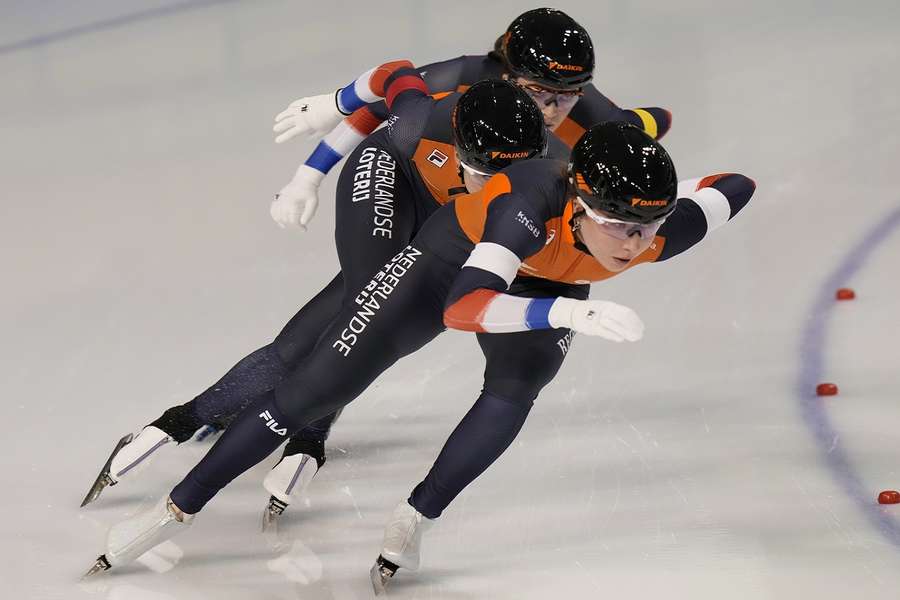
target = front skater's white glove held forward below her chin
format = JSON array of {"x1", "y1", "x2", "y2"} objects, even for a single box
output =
[{"x1": 548, "y1": 298, "x2": 644, "y2": 342}]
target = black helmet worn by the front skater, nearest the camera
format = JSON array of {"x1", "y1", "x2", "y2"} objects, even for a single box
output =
[{"x1": 569, "y1": 121, "x2": 678, "y2": 223}]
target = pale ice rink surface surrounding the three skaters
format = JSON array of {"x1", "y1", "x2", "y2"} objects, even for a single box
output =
[{"x1": 0, "y1": 0, "x2": 900, "y2": 600}]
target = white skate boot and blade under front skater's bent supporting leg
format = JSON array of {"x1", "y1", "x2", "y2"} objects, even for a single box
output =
[{"x1": 369, "y1": 500, "x2": 434, "y2": 595}]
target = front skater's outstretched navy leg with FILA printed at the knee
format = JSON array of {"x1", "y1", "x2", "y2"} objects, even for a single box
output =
[{"x1": 172, "y1": 248, "x2": 456, "y2": 513}]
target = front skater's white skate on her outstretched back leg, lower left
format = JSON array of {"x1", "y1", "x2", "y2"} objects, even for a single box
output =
[{"x1": 84, "y1": 496, "x2": 194, "y2": 577}]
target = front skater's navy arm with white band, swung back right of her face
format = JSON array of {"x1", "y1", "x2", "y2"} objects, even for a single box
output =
[{"x1": 656, "y1": 173, "x2": 756, "y2": 261}]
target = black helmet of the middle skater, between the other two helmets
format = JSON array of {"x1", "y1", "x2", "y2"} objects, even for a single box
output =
[{"x1": 451, "y1": 79, "x2": 547, "y2": 173}]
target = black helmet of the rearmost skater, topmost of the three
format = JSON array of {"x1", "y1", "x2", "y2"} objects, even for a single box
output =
[{"x1": 499, "y1": 8, "x2": 594, "y2": 90}]
